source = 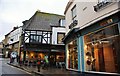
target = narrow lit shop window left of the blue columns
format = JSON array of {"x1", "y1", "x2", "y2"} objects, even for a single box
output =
[{"x1": 68, "y1": 40, "x2": 78, "y2": 69}]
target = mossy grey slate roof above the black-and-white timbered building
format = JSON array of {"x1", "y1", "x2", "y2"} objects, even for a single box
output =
[{"x1": 23, "y1": 11, "x2": 65, "y2": 31}]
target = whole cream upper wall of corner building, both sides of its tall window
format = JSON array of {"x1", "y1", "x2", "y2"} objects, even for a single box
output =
[{"x1": 65, "y1": 0, "x2": 120, "y2": 33}]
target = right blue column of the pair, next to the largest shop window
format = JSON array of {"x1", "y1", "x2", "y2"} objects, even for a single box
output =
[{"x1": 79, "y1": 36, "x2": 85, "y2": 72}]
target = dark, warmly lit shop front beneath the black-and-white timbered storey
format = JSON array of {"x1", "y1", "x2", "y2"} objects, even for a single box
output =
[{"x1": 20, "y1": 43, "x2": 65, "y2": 66}]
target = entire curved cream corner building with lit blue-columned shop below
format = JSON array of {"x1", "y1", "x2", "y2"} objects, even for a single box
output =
[{"x1": 63, "y1": 0, "x2": 120, "y2": 74}]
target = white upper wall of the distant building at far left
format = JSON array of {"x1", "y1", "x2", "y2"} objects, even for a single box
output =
[{"x1": 8, "y1": 27, "x2": 22, "y2": 44}]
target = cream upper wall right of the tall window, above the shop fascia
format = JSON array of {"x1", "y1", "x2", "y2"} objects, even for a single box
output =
[{"x1": 77, "y1": 2, "x2": 118, "y2": 29}]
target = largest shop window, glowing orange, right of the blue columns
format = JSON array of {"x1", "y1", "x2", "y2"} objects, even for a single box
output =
[{"x1": 84, "y1": 24, "x2": 120, "y2": 73}]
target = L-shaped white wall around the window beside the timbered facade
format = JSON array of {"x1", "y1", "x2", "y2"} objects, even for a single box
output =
[{"x1": 52, "y1": 27, "x2": 66, "y2": 44}]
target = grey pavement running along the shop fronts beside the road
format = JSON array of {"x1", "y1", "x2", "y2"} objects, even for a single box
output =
[{"x1": 7, "y1": 60, "x2": 120, "y2": 76}]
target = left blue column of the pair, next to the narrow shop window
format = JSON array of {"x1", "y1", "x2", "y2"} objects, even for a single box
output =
[{"x1": 77, "y1": 37, "x2": 82, "y2": 71}]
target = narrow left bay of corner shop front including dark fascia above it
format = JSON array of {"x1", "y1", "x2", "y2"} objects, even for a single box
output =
[{"x1": 63, "y1": 28, "x2": 80, "y2": 71}]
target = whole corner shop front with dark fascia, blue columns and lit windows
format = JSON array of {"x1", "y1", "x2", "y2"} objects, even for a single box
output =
[{"x1": 64, "y1": 13, "x2": 120, "y2": 74}]
